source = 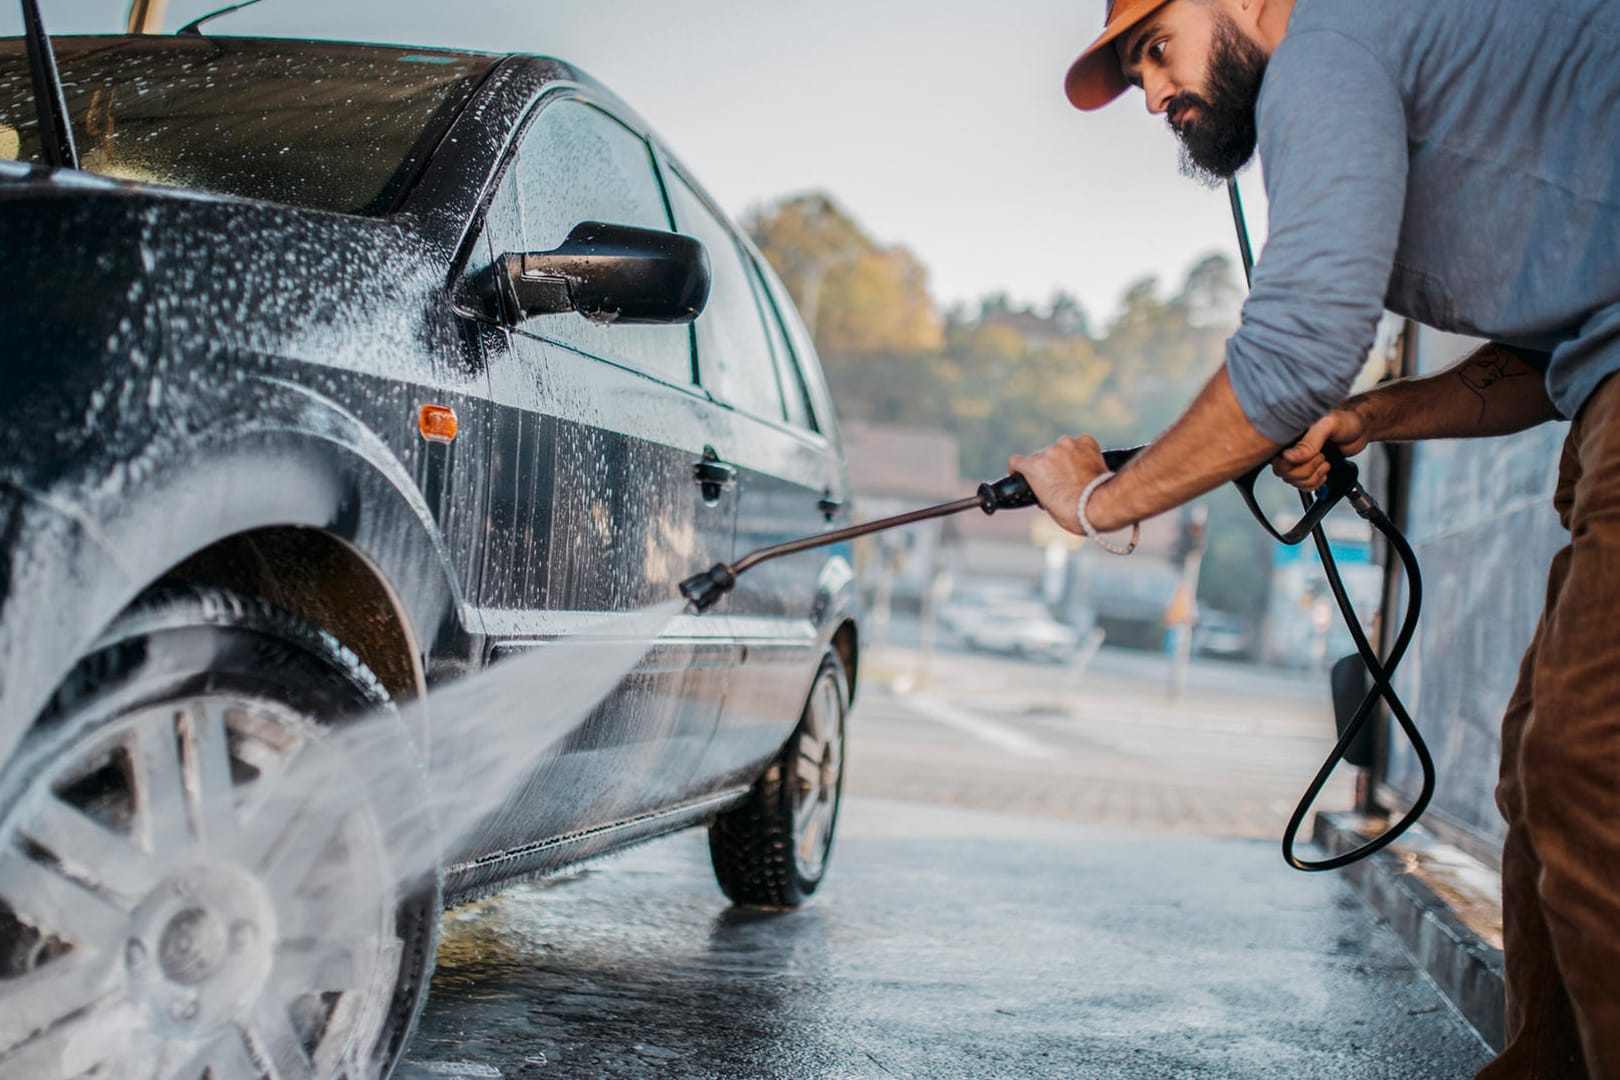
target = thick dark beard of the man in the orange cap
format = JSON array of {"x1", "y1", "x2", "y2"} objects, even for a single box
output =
[{"x1": 1168, "y1": 15, "x2": 1267, "y2": 188}]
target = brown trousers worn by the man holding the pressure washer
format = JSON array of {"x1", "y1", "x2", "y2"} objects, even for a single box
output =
[{"x1": 1479, "y1": 377, "x2": 1620, "y2": 1080}]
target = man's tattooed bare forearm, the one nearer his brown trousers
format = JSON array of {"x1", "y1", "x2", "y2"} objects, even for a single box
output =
[{"x1": 1345, "y1": 345, "x2": 1558, "y2": 442}]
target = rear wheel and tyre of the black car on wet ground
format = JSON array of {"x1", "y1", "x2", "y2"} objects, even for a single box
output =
[{"x1": 710, "y1": 654, "x2": 849, "y2": 908}]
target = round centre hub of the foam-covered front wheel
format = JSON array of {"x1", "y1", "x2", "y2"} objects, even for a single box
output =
[{"x1": 125, "y1": 863, "x2": 275, "y2": 1036}]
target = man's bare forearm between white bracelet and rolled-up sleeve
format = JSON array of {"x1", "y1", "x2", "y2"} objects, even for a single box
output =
[{"x1": 1087, "y1": 368, "x2": 1278, "y2": 531}]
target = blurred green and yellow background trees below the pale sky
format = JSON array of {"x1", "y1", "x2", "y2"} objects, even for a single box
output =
[{"x1": 748, "y1": 194, "x2": 1283, "y2": 619}]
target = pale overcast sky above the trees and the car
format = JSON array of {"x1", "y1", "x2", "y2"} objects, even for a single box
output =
[{"x1": 19, "y1": 0, "x2": 1264, "y2": 321}]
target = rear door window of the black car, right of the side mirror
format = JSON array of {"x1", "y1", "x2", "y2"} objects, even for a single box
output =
[{"x1": 669, "y1": 173, "x2": 786, "y2": 421}]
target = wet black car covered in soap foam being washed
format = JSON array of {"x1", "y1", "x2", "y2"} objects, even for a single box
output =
[{"x1": 0, "y1": 34, "x2": 859, "y2": 1080}]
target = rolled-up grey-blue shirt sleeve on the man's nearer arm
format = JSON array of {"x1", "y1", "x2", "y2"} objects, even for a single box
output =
[{"x1": 1226, "y1": 29, "x2": 1408, "y2": 442}]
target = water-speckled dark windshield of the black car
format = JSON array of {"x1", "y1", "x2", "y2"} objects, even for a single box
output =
[{"x1": 0, "y1": 37, "x2": 496, "y2": 214}]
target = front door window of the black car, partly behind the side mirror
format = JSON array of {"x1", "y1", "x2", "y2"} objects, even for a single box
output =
[{"x1": 488, "y1": 100, "x2": 692, "y2": 384}]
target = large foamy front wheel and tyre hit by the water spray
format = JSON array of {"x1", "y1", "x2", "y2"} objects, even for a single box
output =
[{"x1": 0, "y1": 588, "x2": 442, "y2": 1080}]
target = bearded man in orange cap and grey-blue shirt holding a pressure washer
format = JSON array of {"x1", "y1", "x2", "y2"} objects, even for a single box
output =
[{"x1": 1009, "y1": 0, "x2": 1620, "y2": 1080}]
